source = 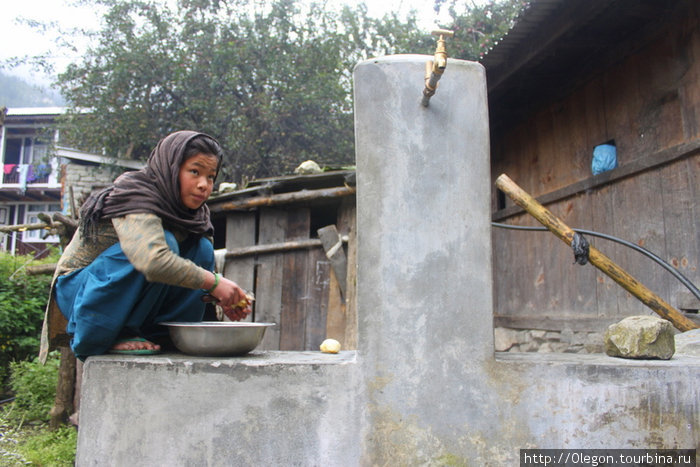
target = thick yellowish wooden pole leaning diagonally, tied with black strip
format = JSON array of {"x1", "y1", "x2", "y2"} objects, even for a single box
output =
[{"x1": 496, "y1": 174, "x2": 699, "y2": 331}]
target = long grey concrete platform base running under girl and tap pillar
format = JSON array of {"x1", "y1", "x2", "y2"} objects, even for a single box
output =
[{"x1": 77, "y1": 351, "x2": 700, "y2": 466}]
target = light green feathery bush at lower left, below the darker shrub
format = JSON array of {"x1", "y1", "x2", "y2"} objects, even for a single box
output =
[{"x1": 7, "y1": 352, "x2": 60, "y2": 422}]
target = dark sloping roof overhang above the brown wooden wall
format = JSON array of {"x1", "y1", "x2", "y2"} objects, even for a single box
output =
[{"x1": 480, "y1": 0, "x2": 697, "y2": 132}]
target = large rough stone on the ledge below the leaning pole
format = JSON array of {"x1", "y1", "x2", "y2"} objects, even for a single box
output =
[{"x1": 605, "y1": 316, "x2": 675, "y2": 360}]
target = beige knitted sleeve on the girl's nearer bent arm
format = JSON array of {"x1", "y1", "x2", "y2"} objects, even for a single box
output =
[{"x1": 112, "y1": 213, "x2": 207, "y2": 289}]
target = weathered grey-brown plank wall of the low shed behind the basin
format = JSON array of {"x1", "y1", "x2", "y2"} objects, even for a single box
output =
[{"x1": 219, "y1": 198, "x2": 356, "y2": 350}]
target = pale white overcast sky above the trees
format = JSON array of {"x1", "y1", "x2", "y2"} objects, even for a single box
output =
[{"x1": 0, "y1": 0, "x2": 446, "y2": 82}]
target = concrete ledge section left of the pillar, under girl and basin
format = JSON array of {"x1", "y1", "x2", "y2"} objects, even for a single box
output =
[{"x1": 76, "y1": 351, "x2": 361, "y2": 466}]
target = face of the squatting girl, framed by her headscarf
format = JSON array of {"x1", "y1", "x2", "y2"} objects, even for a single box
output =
[{"x1": 179, "y1": 153, "x2": 219, "y2": 209}]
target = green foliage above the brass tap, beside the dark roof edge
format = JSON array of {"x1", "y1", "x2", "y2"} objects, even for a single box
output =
[{"x1": 435, "y1": 0, "x2": 530, "y2": 60}]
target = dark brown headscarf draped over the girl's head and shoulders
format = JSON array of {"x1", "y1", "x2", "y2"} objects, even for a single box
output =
[{"x1": 80, "y1": 131, "x2": 221, "y2": 239}]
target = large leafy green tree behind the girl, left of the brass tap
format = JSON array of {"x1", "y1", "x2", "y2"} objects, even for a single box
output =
[{"x1": 58, "y1": 0, "x2": 430, "y2": 180}]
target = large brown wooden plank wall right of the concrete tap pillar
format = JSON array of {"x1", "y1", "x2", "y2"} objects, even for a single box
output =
[{"x1": 492, "y1": 8, "x2": 700, "y2": 331}]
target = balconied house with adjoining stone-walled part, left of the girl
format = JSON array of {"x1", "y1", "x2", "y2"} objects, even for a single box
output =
[{"x1": 0, "y1": 107, "x2": 143, "y2": 254}]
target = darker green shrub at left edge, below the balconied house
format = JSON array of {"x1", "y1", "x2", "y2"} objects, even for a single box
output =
[{"x1": 0, "y1": 252, "x2": 57, "y2": 390}]
